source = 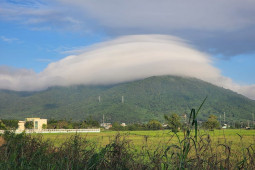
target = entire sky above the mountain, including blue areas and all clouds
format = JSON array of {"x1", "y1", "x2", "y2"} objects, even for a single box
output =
[{"x1": 0, "y1": 0, "x2": 255, "y2": 99}]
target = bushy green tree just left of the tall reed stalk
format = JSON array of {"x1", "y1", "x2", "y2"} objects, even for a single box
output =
[{"x1": 164, "y1": 113, "x2": 181, "y2": 133}]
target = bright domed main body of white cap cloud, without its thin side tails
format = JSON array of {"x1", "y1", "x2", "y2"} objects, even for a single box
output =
[{"x1": 40, "y1": 35, "x2": 219, "y2": 85}]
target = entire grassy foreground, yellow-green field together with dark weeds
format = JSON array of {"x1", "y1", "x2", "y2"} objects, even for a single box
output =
[{"x1": 0, "y1": 130, "x2": 255, "y2": 169}]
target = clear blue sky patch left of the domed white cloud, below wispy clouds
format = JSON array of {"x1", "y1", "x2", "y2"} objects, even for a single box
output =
[{"x1": 0, "y1": 21, "x2": 104, "y2": 72}]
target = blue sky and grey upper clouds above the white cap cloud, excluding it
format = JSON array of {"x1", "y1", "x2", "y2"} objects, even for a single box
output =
[{"x1": 0, "y1": 0, "x2": 255, "y2": 98}]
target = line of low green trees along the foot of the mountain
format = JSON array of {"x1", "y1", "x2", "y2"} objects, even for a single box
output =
[{"x1": 0, "y1": 113, "x2": 254, "y2": 132}]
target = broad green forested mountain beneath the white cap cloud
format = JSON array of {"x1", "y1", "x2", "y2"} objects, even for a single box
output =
[{"x1": 0, "y1": 76, "x2": 255, "y2": 123}]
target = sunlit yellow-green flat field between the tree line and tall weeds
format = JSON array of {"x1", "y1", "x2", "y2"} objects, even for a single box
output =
[{"x1": 34, "y1": 129, "x2": 255, "y2": 148}]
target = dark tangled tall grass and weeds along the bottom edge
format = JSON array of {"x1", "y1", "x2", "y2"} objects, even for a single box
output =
[{"x1": 0, "y1": 132, "x2": 255, "y2": 169}]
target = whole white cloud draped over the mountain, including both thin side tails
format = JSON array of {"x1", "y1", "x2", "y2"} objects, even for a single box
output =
[{"x1": 0, "y1": 35, "x2": 255, "y2": 99}]
